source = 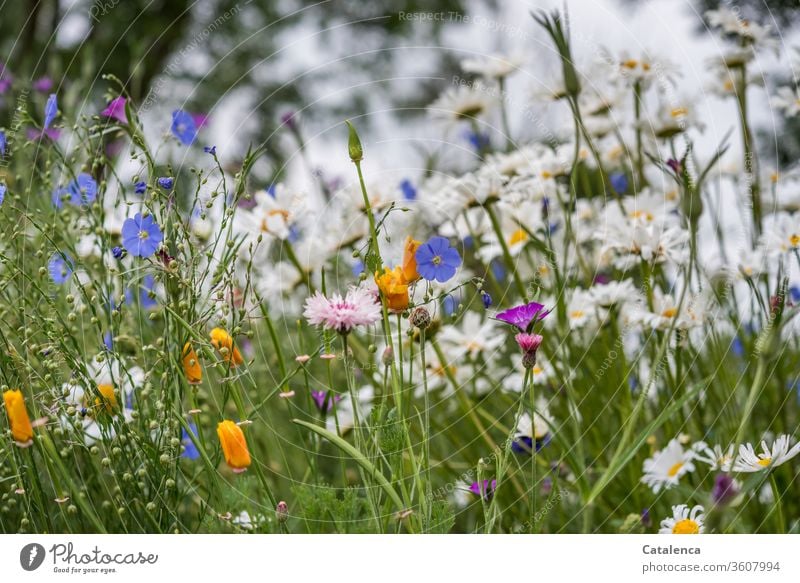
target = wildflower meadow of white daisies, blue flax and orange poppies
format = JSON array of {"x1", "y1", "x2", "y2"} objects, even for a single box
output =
[{"x1": 0, "y1": 2, "x2": 800, "y2": 534}]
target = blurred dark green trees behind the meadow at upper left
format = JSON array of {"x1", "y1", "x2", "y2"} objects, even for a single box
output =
[{"x1": 0, "y1": 0, "x2": 492, "y2": 173}]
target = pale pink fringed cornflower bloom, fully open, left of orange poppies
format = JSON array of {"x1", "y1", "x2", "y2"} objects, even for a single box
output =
[{"x1": 303, "y1": 287, "x2": 382, "y2": 334}]
